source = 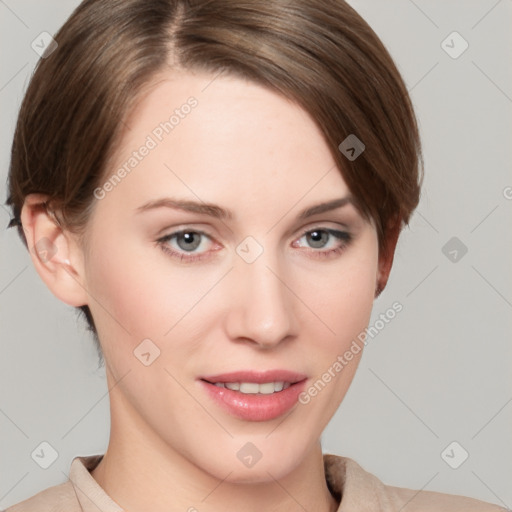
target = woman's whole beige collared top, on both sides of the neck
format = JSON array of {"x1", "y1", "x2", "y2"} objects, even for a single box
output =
[{"x1": 4, "y1": 454, "x2": 506, "y2": 512}]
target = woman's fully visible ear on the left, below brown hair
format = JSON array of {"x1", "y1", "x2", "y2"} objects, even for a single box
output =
[{"x1": 20, "y1": 194, "x2": 88, "y2": 307}]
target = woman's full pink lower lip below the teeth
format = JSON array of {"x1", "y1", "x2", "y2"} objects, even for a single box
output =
[{"x1": 199, "y1": 379, "x2": 306, "y2": 421}]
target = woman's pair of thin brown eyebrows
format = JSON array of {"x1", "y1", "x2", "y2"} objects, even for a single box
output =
[{"x1": 136, "y1": 196, "x2": 354, "y2": 220}]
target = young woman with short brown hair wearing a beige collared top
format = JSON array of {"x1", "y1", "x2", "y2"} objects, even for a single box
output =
[{"x1": 3, "y1": 0, "x2": 508, "y2": 512}]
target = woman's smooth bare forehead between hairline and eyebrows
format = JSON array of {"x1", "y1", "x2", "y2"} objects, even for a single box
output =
[{"x1": 96, "y1": 72, "x2": 349, "y2": 223}]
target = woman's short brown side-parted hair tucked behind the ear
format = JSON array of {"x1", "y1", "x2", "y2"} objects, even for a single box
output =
[{"x1": 6, "y1": 0, "x2": 423, "y2": 360}]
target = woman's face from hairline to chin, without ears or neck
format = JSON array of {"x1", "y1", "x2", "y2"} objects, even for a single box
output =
[{"x1": 78, "y1": 72, "x2": 379, "y2": 482}]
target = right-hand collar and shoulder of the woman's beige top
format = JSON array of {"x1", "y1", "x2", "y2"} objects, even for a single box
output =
[{"x1": 324, "y1": 454, "x2": 506, "y2": 512}]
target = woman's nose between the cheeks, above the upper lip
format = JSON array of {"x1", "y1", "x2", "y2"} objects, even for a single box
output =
[{"x1": 226, "y1": 251, "x2": 297, "y2": 349}]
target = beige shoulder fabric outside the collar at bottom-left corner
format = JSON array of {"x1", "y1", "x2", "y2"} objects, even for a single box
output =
[{"x1": 3, "y1": 480, "x2": 81, "y2": 512}]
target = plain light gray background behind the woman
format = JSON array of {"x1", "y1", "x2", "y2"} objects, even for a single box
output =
[{"x1": 0, "y1": 0, "x2": 512, "y2": 509}]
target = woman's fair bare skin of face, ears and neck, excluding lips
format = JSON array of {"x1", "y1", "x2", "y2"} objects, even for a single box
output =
[{"x1": 22, "y1": 72, "x2": 398, "y2": 512}]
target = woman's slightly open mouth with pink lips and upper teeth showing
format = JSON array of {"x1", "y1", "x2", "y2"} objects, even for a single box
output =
[{"x1": 199, "y1": 370, "x2": 307, "y2": 421}]
